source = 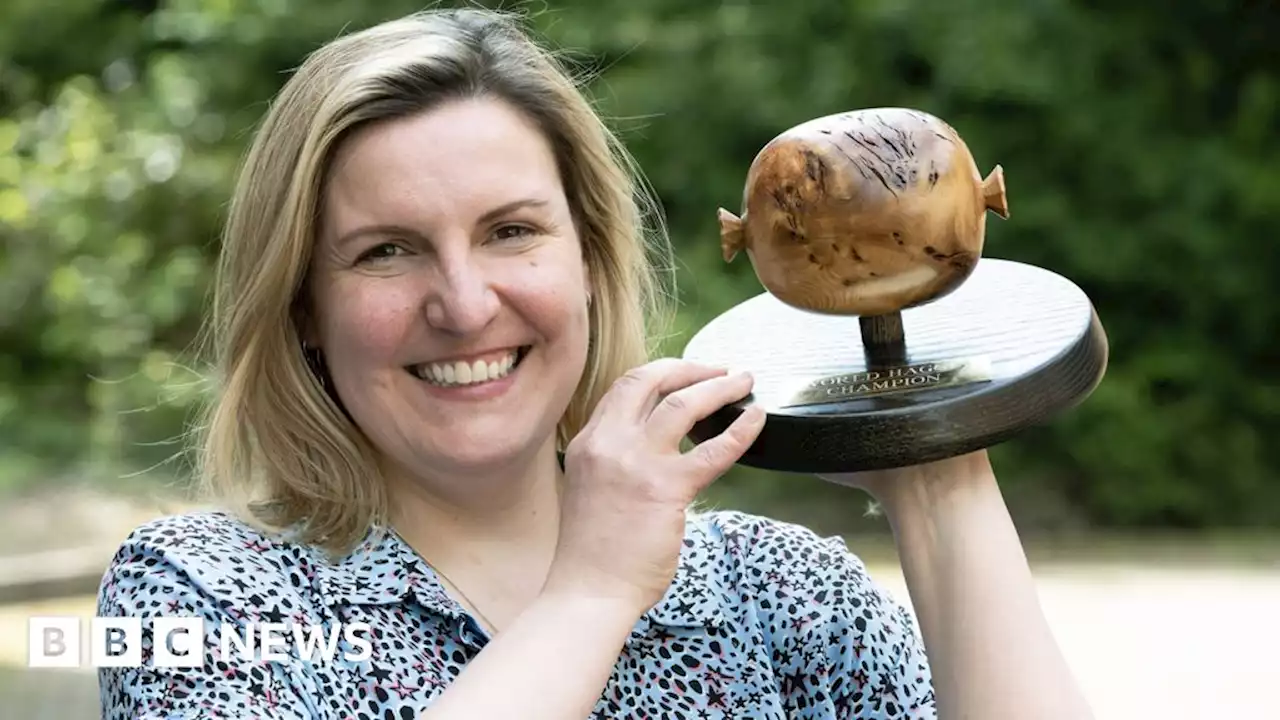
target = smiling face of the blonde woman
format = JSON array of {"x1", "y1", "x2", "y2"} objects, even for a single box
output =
[{"x1": 310, "y1": 99, "x2": 589, "y2": 478}]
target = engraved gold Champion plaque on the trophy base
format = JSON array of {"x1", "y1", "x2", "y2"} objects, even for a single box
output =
[{"x1": 782, "y1": 357, "x2": 991, "y2": 407}]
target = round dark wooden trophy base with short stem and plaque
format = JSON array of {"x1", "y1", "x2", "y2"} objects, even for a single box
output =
[{"x1": 684, "y1": 258, "x2": 1107, "y2": 473}]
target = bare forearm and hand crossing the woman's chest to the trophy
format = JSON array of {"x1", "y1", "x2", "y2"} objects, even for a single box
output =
[{"x1": 424, "y1": 360, "x2": 764, "y2": 720}]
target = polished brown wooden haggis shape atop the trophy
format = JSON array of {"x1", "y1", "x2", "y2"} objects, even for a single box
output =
[{"x1": 719, "y1": 108, "x2": 1009, "y2": 315}]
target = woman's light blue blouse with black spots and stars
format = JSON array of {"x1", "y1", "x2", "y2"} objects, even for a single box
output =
[{"x1": 97, "y1": 511, "x2": 936, "y2": 720}]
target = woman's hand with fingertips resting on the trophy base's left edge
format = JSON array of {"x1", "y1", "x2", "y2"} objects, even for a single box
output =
[{"x1": 544, "y1": 359, "x2": 764, "y2": 615}]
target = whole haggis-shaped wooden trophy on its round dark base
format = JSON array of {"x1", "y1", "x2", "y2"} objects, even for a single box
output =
[{"x1": 684, "y1": 108, "x2": 1107, "y2": 473}]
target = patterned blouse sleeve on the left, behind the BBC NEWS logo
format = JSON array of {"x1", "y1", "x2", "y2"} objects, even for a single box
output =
[{"x1": 97, "y1": 520, "x2": 319, "y2": 720}]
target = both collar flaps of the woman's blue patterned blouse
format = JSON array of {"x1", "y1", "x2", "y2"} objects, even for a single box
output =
[{"x1": 316, "y1": 512, "x2": 732, "y2": 630}]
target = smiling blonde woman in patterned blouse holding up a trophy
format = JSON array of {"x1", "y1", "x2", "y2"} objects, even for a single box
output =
[{"x1": 99, "y1": 10, "x2": 1088, "y2": 720}]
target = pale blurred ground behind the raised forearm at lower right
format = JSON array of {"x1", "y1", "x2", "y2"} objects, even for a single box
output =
[{"x1": 872, "y1": 564, "x2": 1280, "y2": 720}]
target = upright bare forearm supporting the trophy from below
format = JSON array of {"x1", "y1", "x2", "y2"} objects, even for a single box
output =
[{"x1": 827, "y1": 452, "x2": 1093, "y2": 720}]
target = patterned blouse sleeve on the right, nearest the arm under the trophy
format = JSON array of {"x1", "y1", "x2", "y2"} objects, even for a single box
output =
[{"x1": 750, "y1": 515, "x2": 937, "y2": 720}]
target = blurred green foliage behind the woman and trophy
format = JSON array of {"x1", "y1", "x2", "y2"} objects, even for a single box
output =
[{"x1": 0, "y1": 0, "x2": 1280, "y2": 528}]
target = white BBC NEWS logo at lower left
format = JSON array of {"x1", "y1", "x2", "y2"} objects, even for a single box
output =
[{"x1": 27, "y1": 616, "x2": 374, "y2": 667}]
